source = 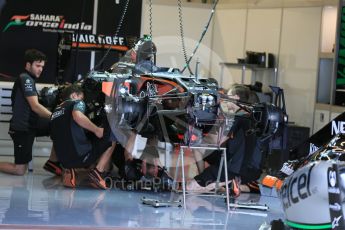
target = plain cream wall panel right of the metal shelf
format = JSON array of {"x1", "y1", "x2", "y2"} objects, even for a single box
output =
[{"x1": 279, "y1": 7, "x2": 322, "y2": 127}]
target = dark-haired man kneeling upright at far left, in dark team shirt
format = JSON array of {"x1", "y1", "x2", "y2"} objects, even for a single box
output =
[{"x1": 0, "y1": 49, "x2": 61, "y2": 175}]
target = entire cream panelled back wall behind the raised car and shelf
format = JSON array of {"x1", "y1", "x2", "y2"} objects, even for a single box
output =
[{"x1": 142, "y1": 0, "x2": 322, "y2": 128}]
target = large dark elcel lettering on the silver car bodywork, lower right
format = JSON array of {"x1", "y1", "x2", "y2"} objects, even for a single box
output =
[{"x1": 281, "y1": 165, "x2": 315, "y2": 209}]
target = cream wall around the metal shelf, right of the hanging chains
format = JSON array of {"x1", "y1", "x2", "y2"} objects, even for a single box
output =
[{"x1": 211, "y1": 7, "x2": 322, "y2": 128}]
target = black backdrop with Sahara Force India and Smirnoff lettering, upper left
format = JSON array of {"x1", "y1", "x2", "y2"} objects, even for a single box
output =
[{"x1": 0, "y1": 0, "x2": 142, "y2": 83}]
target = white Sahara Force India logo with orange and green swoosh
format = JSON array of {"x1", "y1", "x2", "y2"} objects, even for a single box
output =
[{"x1": 2, "y1": 14, "x2": 92, "y2": 32}]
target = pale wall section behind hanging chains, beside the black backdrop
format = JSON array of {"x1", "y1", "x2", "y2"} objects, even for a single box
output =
[{"x1": 142, "y1": 1, "x2": 213, "y2": 76}]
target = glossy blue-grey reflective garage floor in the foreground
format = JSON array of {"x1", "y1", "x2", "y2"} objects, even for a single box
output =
[{"x1": 0, "y1": 155, "x2": 283, "y2": 230}]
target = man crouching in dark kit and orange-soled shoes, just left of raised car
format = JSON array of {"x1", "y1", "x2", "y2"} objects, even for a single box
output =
[{"x1": 51, "y1": 85, "x2": 115, "y2": 189}]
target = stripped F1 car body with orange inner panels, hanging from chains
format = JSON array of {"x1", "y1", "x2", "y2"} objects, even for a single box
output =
[{"x1": 103, "y1": 72, "x2": 219, "y2": 142}]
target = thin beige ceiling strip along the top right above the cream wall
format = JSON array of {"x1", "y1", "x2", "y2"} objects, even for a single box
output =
[{"x1": 190, "y1": 0, "x2": 338, "y2": 8}]
